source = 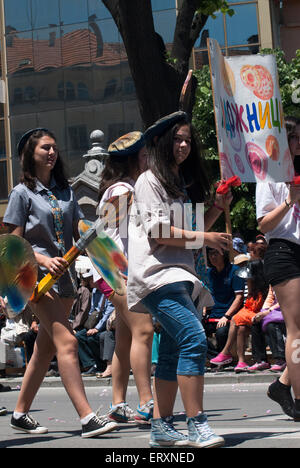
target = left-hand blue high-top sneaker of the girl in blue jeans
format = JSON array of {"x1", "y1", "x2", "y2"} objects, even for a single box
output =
[{"x1": 149, "y1": 418, "x2": 188, "y2": 447}]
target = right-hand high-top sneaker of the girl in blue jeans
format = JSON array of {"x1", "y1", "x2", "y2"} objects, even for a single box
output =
[{"x1": 187, "y1": 413, "x2": 225, "y2": 448}]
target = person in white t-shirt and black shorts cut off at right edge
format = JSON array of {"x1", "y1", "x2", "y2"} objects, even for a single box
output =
[{"x1": 256, "y1": 118, "x2": 300, "y2": 421}]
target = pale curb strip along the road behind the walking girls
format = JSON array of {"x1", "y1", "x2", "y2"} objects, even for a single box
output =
[{"x1": 0, "y1": 368, "x2": 280, "y2": 389}]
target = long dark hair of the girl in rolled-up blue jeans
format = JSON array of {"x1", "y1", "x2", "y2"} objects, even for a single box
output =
[{"x1": 148, "y1": 120, "x2": 210, "y2": 203}]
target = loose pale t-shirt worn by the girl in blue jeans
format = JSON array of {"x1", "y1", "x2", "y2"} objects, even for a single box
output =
[{"x1": 127, "y1": 170, "x2": 214, "y2": 312}]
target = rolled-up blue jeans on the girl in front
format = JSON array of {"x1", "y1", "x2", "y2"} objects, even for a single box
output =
[{"x1": 142, "y1": 281, "x2": 207, "y2": 381}]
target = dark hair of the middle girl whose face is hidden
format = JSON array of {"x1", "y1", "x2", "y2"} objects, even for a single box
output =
[{"x1": 98, "y1": 151, "x2": 139, "y2": 201}]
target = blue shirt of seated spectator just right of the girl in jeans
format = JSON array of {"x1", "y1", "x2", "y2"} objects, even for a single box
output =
[{"x1": 208, "y1": 263, "x2": 245, "y2": 318}]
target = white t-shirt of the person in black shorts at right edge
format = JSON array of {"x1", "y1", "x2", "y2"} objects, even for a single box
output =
[{"x1": 256, "y1": 182, "x2": 300, "y2": 244}]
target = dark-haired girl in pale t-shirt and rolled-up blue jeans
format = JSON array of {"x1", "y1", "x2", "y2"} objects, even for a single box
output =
[{"x1": 128, "y1": 111, "x2": 231, "y2": 447}]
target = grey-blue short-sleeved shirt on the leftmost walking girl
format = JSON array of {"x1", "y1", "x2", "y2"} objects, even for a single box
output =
[{"x1": 3, "y1": 177, "x2": 84, "y2": 296}]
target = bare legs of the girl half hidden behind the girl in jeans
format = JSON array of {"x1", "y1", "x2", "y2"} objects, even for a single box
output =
[{"x1": 110, "y1": 294, "x2": 153, "y2": 405}]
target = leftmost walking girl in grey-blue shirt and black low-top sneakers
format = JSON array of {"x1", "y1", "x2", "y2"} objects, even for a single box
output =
[{"x1": 4, "y1": 128, "x2": 117, "y2": 438}]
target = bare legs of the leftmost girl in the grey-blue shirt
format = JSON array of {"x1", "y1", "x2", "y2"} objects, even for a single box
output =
[{"x1": 16, "y1": 291, "x2": 92, "y2": 418}]
